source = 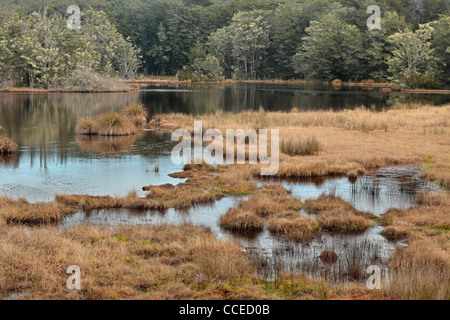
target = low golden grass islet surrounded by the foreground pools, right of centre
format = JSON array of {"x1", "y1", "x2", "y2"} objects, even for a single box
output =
[{"x1": 220, "y1": 181, "x2": 376, "y2": 236}]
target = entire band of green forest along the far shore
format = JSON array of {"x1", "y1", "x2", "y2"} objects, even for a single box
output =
[{"x1": 0, "y1": 0, "x2": 450, "y2": 89}]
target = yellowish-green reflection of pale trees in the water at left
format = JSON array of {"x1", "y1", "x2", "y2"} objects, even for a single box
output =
[{"x1": 0, "y1": 93, "x2": 139, "y2": 164}]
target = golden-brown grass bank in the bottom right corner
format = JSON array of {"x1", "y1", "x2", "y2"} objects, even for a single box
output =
[{"x1": 380, "y1": 192, "x2": 450, "y2": 300}]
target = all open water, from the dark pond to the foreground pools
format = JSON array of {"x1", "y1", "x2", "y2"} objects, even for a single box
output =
[{"x1": 0, "y1": 84, "x2": 442, "y2": 277}]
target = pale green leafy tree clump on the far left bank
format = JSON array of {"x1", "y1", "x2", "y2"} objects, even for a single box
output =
[{"x1": 0, "y1": 8, "x2": 140, "y2": 90}]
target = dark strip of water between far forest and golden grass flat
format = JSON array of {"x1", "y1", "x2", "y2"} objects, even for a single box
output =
[{"x1": 141, "y1": 83, "x2": 450, "y2": 114}]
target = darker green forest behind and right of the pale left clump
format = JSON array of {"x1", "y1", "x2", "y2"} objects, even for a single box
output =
[{"x1": 0, "y1": 0, "x2": 450, "y2": 88}]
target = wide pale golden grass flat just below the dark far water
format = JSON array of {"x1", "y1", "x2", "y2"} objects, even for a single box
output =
[{"x1": 155, "y1": 104, "x2": 450, "y2": 186}]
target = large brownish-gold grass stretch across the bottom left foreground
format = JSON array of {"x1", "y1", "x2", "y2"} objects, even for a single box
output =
[{"x1": 0, "y1": 225, "x2": 267, "y2": 300}]
